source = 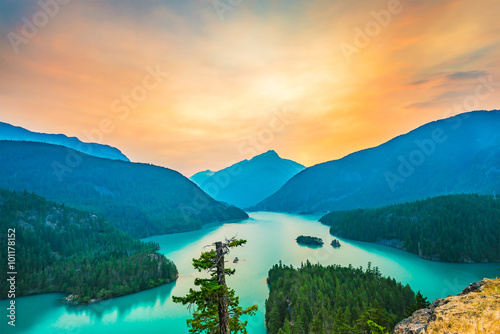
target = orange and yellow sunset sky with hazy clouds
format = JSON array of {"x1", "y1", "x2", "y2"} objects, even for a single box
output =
[{"x1": 0, "y1": 0, "x2": 500, "y2": 176}]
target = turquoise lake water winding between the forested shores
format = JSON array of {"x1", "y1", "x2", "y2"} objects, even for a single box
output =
[{"x1": 0, "y1": 212, "x2": 500, "y2": 334}]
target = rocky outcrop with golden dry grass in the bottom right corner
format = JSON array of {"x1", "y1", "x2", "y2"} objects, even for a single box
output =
[{"x1": 394, "y1": 277, "x2": 500, "y2": 334}]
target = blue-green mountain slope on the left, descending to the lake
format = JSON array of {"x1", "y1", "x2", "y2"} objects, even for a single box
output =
[{"x1": 0, "y1": 141, "x2": 248, "y2": 237}]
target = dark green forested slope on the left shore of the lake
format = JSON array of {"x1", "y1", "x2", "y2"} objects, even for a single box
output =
[{"x1": 0, "y1": 189, "x2": 177, "y2": 304}]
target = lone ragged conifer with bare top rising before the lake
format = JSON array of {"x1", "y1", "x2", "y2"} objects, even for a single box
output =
[{"x1": 173, "y1": 238, "x2": 257, "y2": 334}]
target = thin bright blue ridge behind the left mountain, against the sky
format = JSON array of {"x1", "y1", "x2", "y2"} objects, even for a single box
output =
[{"x1": 0, "y1": 122, "x2": 130, "y2": 161}]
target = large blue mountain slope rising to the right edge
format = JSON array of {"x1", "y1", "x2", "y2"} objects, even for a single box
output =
[{"x1": 251, "y1": 110, "x2": 500, "y2": 212}]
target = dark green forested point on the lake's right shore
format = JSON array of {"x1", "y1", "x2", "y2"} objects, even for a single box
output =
[{"x1": 320, "y1": 195, "x2": 500, "y2": 262}]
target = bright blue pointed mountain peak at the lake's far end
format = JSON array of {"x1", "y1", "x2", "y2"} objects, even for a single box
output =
[{"x1": 193, "y1": 150, "x2": 305, "y2": 208}]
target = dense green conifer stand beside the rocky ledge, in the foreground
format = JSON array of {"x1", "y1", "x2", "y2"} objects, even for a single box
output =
[{"x1": 266, "y1": 262, "x2": 416, "y2": 334}]
